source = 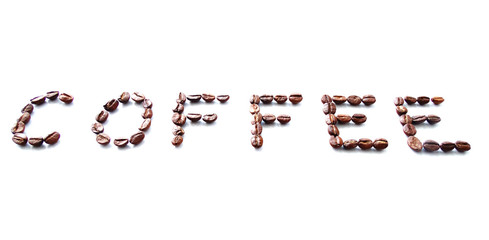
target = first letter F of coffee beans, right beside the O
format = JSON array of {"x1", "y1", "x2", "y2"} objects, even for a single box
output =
[{"x1": 171, "y1": 92, "x2": 229, "y2": 146}]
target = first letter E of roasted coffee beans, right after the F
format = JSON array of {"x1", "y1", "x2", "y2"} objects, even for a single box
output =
[{"x1": 321, "y1": 94, "x2": 389, "y2": 150}]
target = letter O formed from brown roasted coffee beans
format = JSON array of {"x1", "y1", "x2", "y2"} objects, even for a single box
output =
[{"x1": 92, "y1": 92, "x2": 153, "y2": 148}]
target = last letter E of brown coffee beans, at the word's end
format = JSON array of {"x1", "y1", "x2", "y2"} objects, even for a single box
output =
[{"x1": 394, "y1": 96, "x2": 470, "y2": 152}]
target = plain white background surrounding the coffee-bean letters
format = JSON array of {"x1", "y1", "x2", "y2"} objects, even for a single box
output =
[{"x1": 0, "y1": 0, "x2": 489, "y2": 240}]
